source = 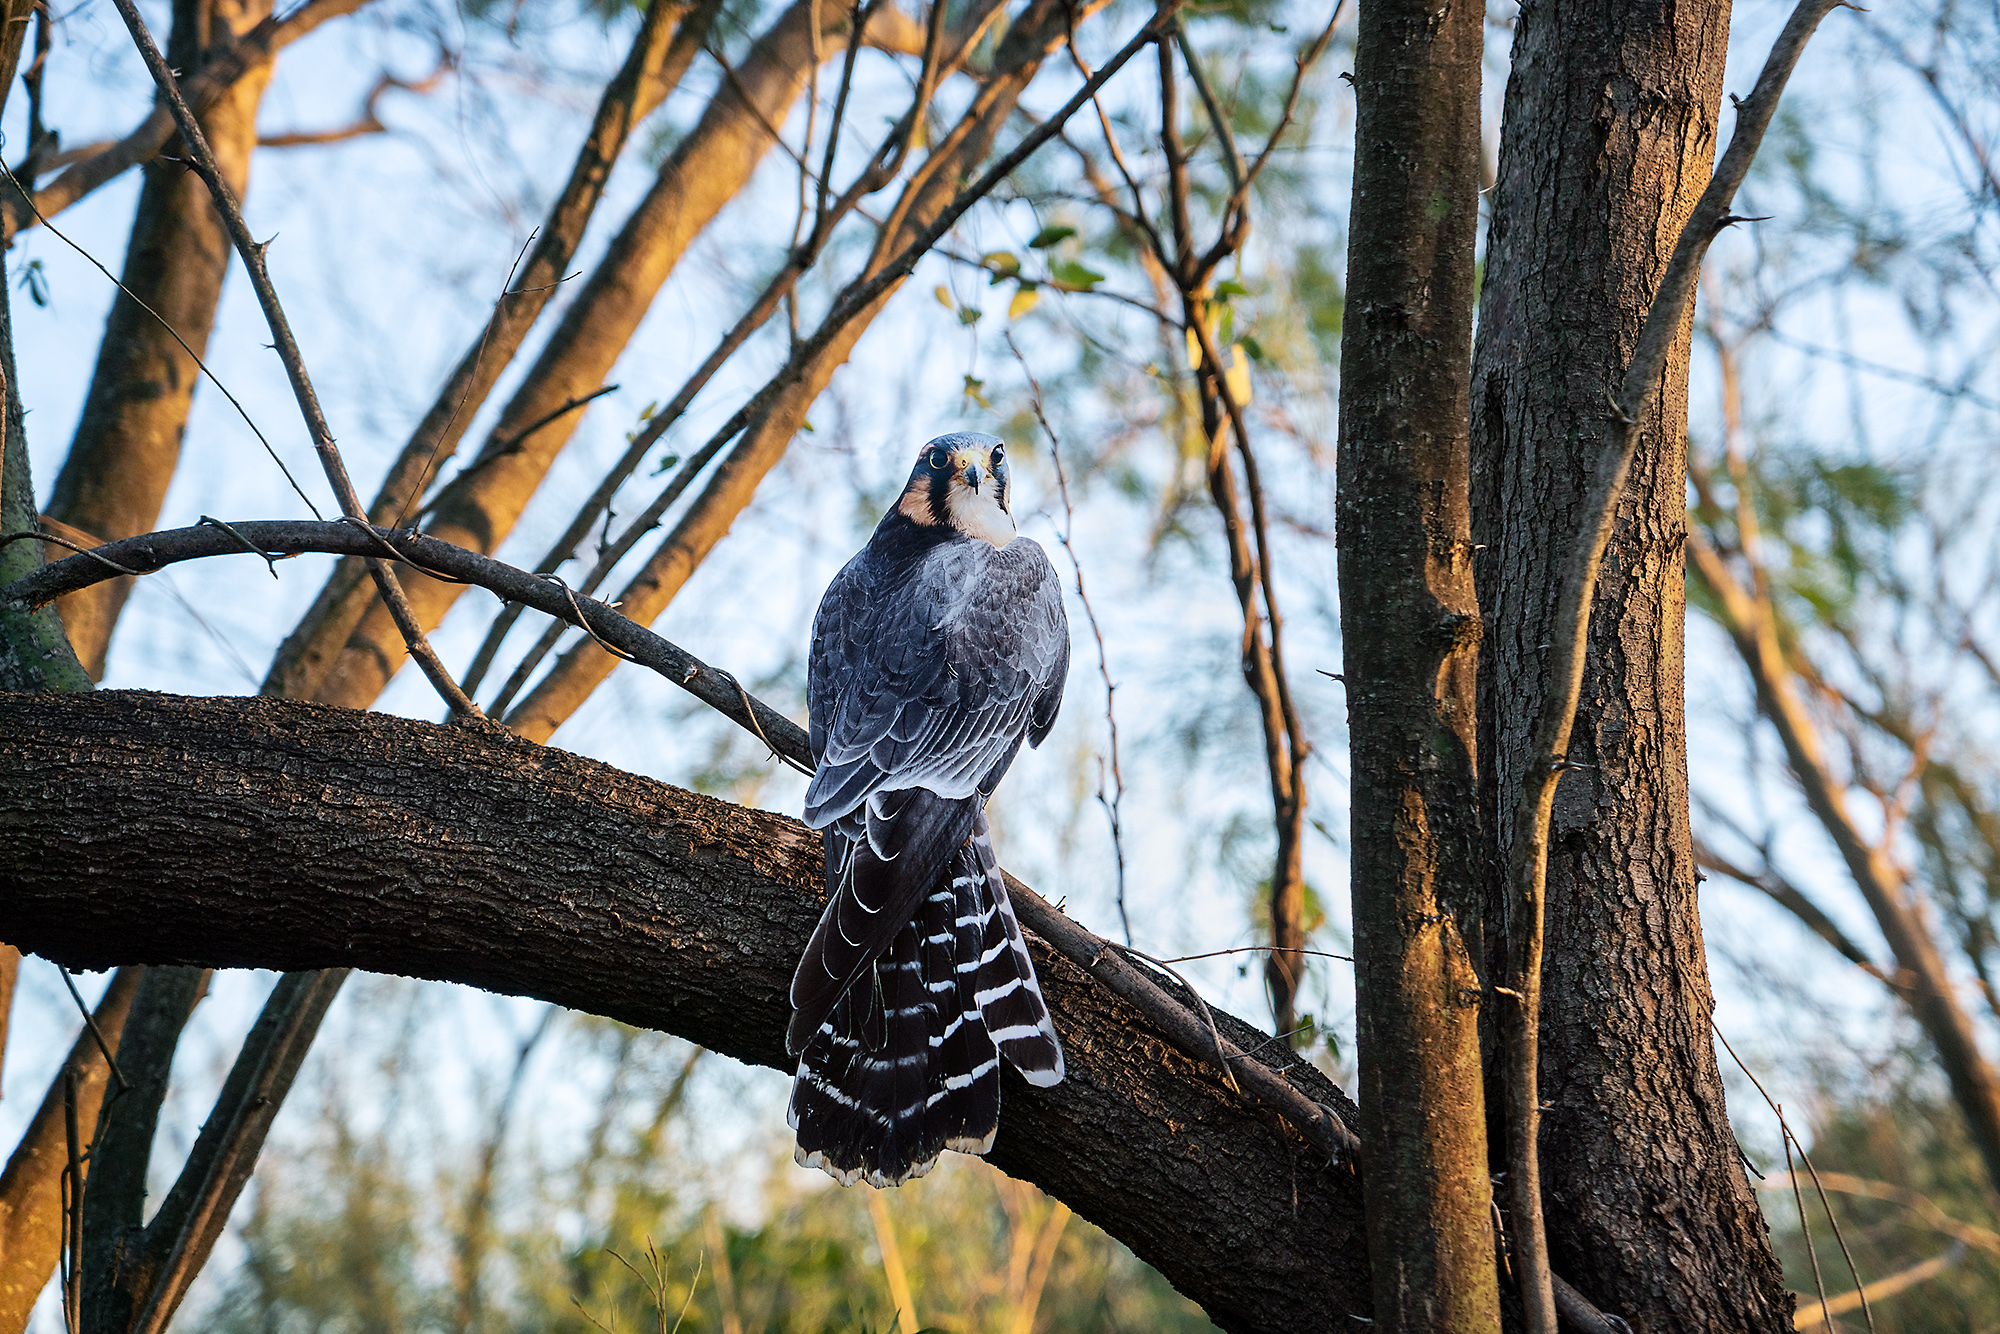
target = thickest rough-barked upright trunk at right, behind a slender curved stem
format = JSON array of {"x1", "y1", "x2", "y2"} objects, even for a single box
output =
[{"x1": 1472, "y1": 0, "x2": 1792, "y2": 1330}]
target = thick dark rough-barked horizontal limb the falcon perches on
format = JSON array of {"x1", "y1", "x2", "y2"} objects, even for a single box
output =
[{"x1": 0, "y1": 692, "x2": 1370, "y2": 1330}]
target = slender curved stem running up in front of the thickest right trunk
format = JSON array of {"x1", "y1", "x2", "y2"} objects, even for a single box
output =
[{"x1": 1506, "y1": 0, "x2": 1840, "y2": 1334}]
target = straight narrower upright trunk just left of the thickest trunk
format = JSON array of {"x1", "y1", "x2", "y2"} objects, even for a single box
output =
[{"x1": 1336, "y1": 0, "x2": 1500, "y2": 1334}]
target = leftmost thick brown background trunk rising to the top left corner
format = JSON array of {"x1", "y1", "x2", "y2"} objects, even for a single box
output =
[{"x1": 48, "y1": 0, "x2": 272, "y2": 680}]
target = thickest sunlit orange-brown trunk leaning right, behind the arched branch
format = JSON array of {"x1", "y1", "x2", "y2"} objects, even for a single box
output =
[{"x1": 288, "y1": 0, "x2": 928, "y2": 708}]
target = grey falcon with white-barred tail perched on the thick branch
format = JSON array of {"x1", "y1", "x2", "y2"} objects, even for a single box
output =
[{"x1": 786, "y1": 434, "x2": 1070, "y2": 1186}]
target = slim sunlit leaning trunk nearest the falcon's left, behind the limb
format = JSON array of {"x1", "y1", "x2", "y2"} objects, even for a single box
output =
[{"x1": 506, "y1": 0, "x2": 1074, "y2": 742}]
